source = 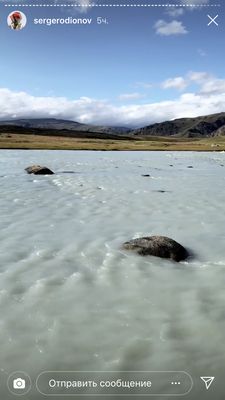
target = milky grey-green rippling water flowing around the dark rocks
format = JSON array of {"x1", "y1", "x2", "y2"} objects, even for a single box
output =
[{"x1": 0, "y1": 150, "x2": 225, "y2": 400}]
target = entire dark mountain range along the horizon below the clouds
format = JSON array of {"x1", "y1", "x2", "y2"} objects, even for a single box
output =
[{"x1": 0, "y1": 112, "x2": 225, "y2": 139}]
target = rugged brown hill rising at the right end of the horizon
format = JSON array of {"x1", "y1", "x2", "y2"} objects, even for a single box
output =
[{"x1": 132, "y1": 112, "x2": 225, "y2": 138}]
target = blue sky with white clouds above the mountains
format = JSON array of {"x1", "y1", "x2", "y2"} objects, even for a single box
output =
[{"x1": 0, "y1": 0, "x2": 225, "y2": 127}]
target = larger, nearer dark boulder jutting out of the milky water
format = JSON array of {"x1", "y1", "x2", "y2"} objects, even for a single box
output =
[{"x1": 123, "y1": 236, "x2": 189, "y2": 261}]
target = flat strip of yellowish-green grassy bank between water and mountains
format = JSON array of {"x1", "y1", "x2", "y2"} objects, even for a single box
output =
[{"x1": 0, "y1": 134, "x2": 225, "y2": 151}]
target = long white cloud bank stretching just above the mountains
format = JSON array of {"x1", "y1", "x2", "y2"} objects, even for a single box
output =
[{"x1": 0, "y1": 72, "x2": 225, "y2": 127}]
